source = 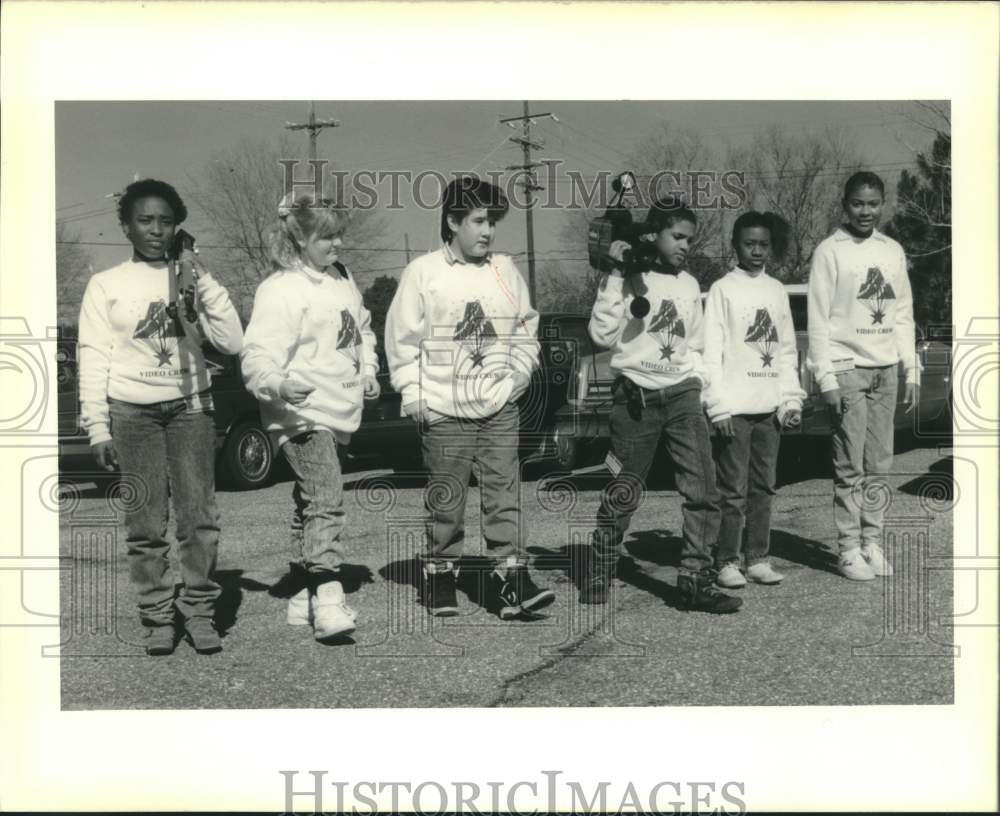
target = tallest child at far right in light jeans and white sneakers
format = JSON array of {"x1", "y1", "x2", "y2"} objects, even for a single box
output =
[{"x1": 808, "y1": 172, "x2": 920, "y2": 581}]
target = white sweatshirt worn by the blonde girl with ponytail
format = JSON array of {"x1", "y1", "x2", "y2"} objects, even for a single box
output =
[{"x1": 240, "y1": 264, "x2": 378, "y2": 446}]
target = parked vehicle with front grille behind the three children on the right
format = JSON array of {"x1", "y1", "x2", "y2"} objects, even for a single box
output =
[{"x1": 554, "y1": 284, "x2": 951, "y2": 470}]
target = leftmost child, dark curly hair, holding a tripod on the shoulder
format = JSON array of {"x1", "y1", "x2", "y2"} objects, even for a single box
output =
[{"x1": 79, "y1": 179, "x2": 243, "y2": 655}]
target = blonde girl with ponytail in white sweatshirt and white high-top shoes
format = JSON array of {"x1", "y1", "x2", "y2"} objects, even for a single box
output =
[{"x1": 241, "y1": 193, "x2": 379, "y2": 641}]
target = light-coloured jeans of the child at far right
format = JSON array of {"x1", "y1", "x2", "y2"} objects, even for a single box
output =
[{"x1": 833, "y1": 365, "x2": 898, "y2": 552}]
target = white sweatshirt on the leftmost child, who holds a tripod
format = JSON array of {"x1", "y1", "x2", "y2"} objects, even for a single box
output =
[{"x1": 79, "y1": 260, "x2": 243, "y2": 445}]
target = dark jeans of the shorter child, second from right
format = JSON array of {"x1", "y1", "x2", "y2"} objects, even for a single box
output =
[{"x1": 712, "y1": 412, "x2": 781, "y2": 568}]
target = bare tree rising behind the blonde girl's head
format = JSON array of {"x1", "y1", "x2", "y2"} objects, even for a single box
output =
[{"x1": 190, "y1": 137, "x2": 386, "y2": 317}]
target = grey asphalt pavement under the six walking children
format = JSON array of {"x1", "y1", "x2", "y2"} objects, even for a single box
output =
[{"x1": 60, "y1": 440, "x2": 954, "y2": 710}]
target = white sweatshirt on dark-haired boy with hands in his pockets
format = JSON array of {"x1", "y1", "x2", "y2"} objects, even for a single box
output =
[{"x1": 385, "y1": 246, "x2": 539, "y2": 419}]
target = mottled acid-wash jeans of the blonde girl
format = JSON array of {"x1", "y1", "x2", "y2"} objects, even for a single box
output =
[{"x1": 281, "y1": 430, "x2": 344, "y2": 575}]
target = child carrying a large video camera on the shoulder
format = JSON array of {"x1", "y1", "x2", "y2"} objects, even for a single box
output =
[{"x1": 580, "y1": 199, "x2": 742, "y2": 613}]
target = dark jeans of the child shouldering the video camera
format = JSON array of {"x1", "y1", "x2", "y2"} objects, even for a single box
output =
[{"x1": 593, "y1": 377, "x2": 720, "y2": 573}]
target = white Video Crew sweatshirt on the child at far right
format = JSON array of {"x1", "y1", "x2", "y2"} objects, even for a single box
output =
[{"x1": 808, "y1": 227, "x2": 919, "y2": 391}]
